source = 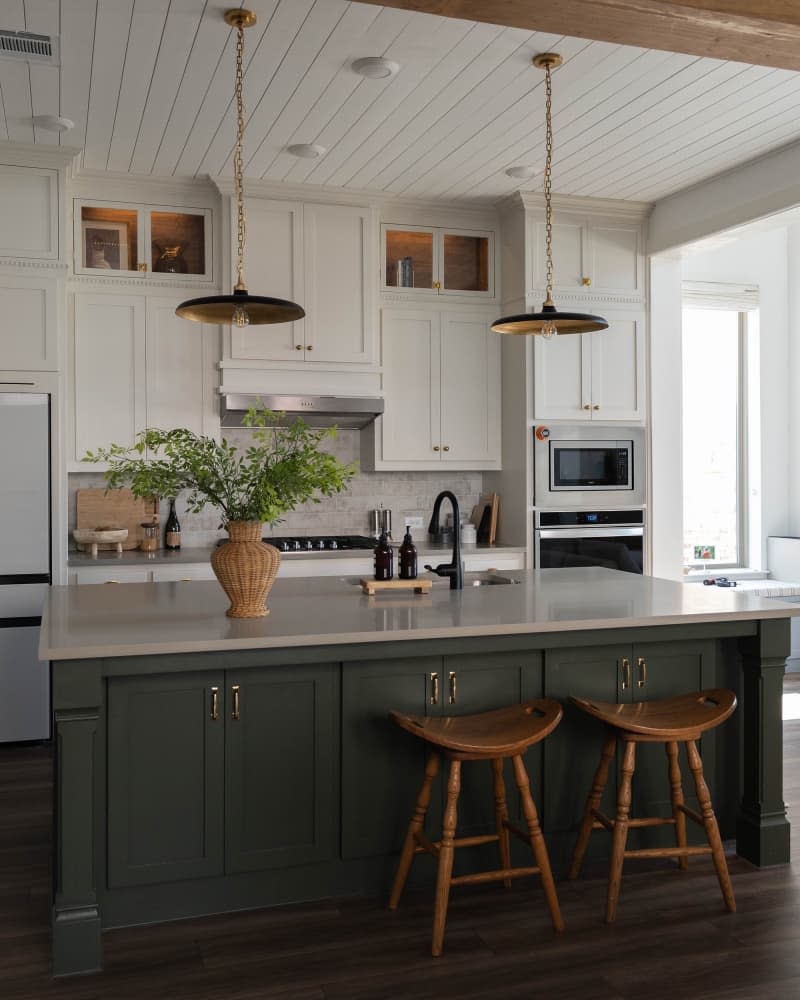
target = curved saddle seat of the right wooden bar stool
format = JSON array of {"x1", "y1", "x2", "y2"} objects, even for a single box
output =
[{"x1": 570, "y1": 688, "x2": 736, "y2": 742}]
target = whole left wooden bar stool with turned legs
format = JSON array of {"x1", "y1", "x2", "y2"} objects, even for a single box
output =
[{"x1": 389, "y1": 698, "x2": 564, "y2": 956}]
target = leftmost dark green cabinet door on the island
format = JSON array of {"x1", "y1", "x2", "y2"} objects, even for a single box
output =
[{"x1": 108, "y1": 672, "x2": 225, "y2": 888}]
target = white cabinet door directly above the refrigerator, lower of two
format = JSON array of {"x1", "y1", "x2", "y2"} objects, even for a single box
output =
[{"x1": 0, "y1": 274, "x2": 58, "y2": 371}]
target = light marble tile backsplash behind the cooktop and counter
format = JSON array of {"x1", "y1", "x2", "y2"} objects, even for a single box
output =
[{"x1": 69, "y1": 428, "x2": 483, "y2": 548}]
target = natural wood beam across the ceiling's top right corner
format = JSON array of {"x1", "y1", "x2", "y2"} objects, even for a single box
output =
[{"x1": 354, "y1": 0, "x2": 800, "y2": 70}]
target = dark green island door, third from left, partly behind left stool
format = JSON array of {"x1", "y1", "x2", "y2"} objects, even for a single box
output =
[{"x1": 342, "y1": 656, "x2": 447, "y2": 860}]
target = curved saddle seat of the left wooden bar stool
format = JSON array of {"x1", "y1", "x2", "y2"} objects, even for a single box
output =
[{"x1": 391, "y1": 698, "x2": 563, "y2": 760}]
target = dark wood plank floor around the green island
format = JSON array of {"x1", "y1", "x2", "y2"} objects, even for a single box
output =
[{"x1": 0, "y1": 678, "x2": 800, "y2": 1000}]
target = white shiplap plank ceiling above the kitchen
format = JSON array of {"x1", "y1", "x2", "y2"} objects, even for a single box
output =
[{"x1": 0, "y1": 0, "x2": 800, "y2": 201}]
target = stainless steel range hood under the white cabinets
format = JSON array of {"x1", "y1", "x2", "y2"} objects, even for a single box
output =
[{"x1": 220, "y1": 392, "x2": 383, "y2": 430}]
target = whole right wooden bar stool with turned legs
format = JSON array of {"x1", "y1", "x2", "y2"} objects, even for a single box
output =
[{"x1": 569, "y1": 689, "x2": 736, "y2": 923}]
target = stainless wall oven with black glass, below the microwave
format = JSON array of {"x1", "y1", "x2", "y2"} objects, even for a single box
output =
[{"x1": 534, "y1": 509, "x2": 645, "y2": 573}]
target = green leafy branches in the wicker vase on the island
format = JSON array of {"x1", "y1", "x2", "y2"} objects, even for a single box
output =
[{"x1": 83, "y1": 407, "x2": 358, "y2": 528}]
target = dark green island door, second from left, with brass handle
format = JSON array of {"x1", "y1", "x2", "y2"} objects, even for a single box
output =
[{"x1": 225, "y1": 663, "x2": 339, "y2": 872}]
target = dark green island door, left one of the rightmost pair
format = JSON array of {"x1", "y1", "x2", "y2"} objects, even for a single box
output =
[{"x1": 542, "y1": 645, "x2": 631, "y2": 874}]
